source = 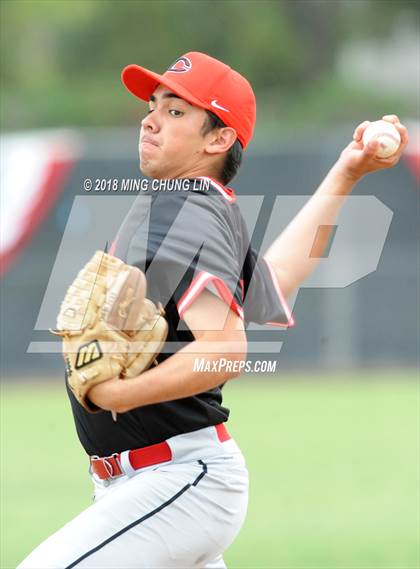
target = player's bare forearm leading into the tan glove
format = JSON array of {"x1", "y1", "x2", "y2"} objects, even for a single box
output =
[{"x1": 89, "y1": 341, "x2": 246, "y2": 413}]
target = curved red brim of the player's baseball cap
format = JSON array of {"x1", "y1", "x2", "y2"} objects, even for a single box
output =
[{"x1": 121, "y1": 64, "x2": 211, "y2": 109}]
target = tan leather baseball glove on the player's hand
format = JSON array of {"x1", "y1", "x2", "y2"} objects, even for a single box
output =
[{"x1": 52, "y1": 251, "x2": 168, "y2": 419}]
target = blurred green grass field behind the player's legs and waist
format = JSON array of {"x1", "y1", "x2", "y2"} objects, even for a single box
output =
[{"x1": 0, "y1": 371, "x2": 420, "y2": 569}]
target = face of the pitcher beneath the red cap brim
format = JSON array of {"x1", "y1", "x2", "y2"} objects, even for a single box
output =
[{"x1": 139, "y1": 85, "x2": 213, "y2": 178}]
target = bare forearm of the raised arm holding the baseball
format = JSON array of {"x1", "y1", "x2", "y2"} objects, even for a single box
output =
[{"x1": 264, "y1": 164, "x2": 355, "y2": 297}]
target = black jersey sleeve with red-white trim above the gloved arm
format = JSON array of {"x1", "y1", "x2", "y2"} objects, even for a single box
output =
[{"x1": 128, "y1": 192, "x2": 243, "y2": 318}]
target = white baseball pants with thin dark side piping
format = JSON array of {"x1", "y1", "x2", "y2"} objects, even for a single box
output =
[{"x1": 18, "y1": 427, "x2": 248, "y2": 569}]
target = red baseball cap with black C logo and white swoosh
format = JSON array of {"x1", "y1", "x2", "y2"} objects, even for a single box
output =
[{"x1": 121, "y1": 51, "x2": 256, "y2": 148}]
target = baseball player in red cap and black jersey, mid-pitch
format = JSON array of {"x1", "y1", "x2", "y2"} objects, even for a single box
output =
[{"x1": 19, "y1": 52, "x2": 407, "y2": 569}]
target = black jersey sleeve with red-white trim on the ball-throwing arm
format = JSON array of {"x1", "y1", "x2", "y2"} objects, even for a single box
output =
[{"x1": 243, "y1": 247, "x2": 295, "y2": 327}]
